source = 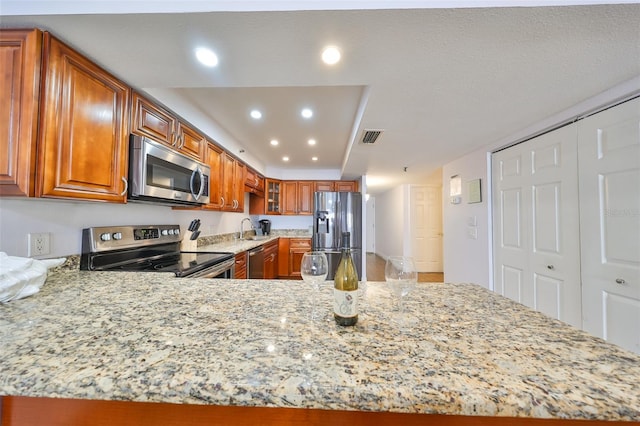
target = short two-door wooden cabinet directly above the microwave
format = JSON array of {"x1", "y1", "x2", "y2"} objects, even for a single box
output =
[{"x1": 131, "y1": 92, "x2": 207, "y2": 161}]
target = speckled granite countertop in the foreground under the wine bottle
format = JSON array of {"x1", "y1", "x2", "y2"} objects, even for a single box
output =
[{"x1": 0, "y1": 270, "x2": 640, "y2": 421}]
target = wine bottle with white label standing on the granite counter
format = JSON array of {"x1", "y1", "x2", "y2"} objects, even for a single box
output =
[{"x1": 333, "y1": 232, "x2": 358, "y2": 326}]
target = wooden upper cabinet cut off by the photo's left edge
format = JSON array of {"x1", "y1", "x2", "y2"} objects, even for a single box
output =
[{"x1": 0, "y1": 30, "x2": 42, "y2": 196}]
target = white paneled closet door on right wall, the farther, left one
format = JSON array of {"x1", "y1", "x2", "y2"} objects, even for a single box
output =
[{"x1": 492, "y1": 125, "x2": 582, "y2": 328}]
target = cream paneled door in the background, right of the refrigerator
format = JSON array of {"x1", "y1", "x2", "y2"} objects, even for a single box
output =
[{"x1": 409, "y1": 185, "x2": 443, "y2": 272}]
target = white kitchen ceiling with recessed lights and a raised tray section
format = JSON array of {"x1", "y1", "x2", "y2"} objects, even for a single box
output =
[{"x1": 0, "y1": 0, "x2": 640, "y2": 194}]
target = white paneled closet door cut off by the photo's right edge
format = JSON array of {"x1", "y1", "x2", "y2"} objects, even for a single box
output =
[{"x1": 578, "y1": 99, "x2": 640, "y2": 353}]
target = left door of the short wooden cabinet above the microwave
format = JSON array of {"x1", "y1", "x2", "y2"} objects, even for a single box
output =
[{"x1": 131, "y1": 92, "x2": 177, "y2": 146}]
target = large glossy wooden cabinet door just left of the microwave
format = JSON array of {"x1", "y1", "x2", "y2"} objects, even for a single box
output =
[{"x1": 37, "y1": 33, "x2": 129, "y2": 203}]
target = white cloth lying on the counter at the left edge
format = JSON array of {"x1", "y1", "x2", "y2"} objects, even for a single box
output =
[{"x1": 0, "y1": 252, "x2": 66, "y2": 303}]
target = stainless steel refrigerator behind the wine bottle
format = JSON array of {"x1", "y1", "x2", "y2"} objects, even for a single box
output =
[{"x1": 311, "y1": 192, "x2": 362, "y2": 280}]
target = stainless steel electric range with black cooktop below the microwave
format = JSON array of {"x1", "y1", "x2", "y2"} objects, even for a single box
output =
[{"x1": 80, "y1": 225, "x2": 235, "y2": 278}]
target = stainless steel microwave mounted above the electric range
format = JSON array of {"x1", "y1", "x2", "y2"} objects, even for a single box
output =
[{"x1": 128, "y1": 135, "x2": 211, "y2": 205}]
